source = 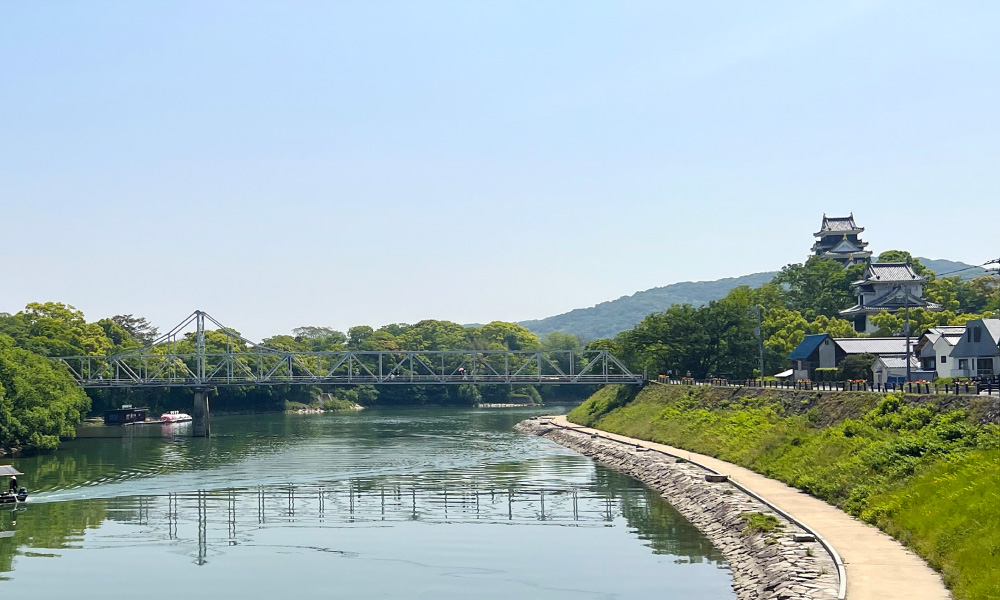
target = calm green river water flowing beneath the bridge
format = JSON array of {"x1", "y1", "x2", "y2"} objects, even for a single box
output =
[{"x1": 0, "y1": 407, "x2": 734, "y2": 600}]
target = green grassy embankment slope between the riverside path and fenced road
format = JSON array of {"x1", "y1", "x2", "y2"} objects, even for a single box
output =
[{"x1": 569, "y1": 385, "x2": 1000, "y2": 600}]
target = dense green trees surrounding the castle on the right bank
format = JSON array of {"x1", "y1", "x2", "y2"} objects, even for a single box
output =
[{"x1": 591, "y1": 250, "x2": 998, "y2": 378}]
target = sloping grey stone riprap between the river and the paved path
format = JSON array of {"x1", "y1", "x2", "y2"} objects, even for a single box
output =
[{"x1": 515, "y1": 417, "x2": 840, "y2": 600}]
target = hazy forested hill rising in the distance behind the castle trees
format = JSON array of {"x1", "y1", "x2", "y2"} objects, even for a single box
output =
[{"x1": 521, "y1": 258, "x2": 987, "y2": 340}]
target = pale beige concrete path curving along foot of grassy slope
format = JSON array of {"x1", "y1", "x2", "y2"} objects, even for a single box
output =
[{"x1": 545, "y1": 415, "x2": 951, "y2": 600}]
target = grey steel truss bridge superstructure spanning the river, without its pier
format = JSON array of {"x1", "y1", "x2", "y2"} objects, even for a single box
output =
[{"x1": 55, "y1": 310, "x2": 643, "y2": 388}]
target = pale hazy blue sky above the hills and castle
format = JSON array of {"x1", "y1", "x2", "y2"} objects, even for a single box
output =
[{"x1": 0, "y1": 0, "x2": 1000, "y2": 338}]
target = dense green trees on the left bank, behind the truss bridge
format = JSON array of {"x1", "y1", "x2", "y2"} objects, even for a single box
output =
[{"x1": 0, "y1": 302, "x2": 593, "y2": 449}]
